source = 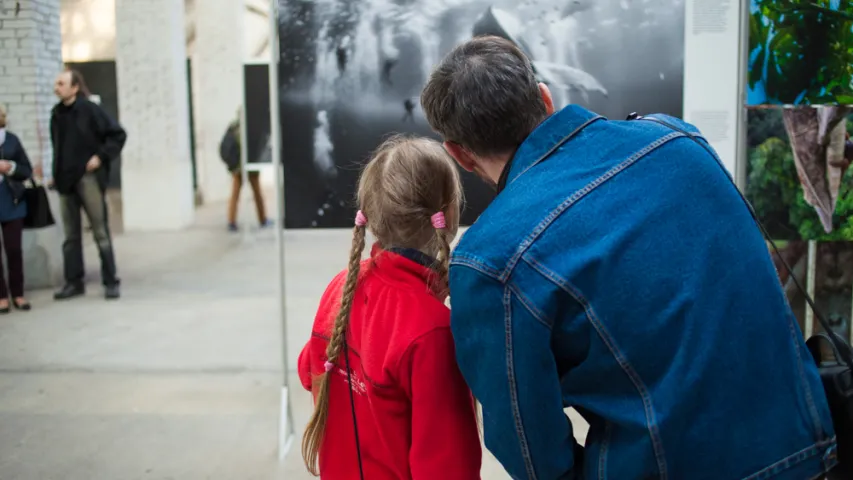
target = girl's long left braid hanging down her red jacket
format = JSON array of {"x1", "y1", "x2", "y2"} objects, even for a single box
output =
[{"x1": 302, "y1": 226, "x2": 365, "y2": 476}]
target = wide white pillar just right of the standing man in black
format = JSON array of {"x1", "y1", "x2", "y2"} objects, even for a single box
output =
[{"x1": 116, "y1": 0, "x2": 194, "y2": 230}]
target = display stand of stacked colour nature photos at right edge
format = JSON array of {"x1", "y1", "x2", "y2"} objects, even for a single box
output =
[{"x1": 743, "y1": 0, "x2": 853, "y2": 344}]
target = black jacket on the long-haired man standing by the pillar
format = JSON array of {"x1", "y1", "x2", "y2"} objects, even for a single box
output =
[{"x1": 50, "y1": 96, "x2": 127, "y2": 194}]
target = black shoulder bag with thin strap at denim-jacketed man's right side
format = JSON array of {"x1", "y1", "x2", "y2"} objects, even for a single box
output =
[{"x1": 628, "y1": 113, "x2": 853, "y2": 480}]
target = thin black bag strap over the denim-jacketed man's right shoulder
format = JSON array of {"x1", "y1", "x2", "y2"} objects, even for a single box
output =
[{"x1": 628, "y1": 113, "x2": 853, "y2": 369}]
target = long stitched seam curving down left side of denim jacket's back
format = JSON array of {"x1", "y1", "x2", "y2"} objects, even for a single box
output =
[{"x1": 523, "y1": 255, "x2": 668, "y2": 480}]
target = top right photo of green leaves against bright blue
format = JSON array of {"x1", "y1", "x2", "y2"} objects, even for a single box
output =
[{"x1": 746, "y1": 0, "x2": 853, "y2": 105}]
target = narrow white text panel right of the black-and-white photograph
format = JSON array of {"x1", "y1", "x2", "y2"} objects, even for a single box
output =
[{"x1": 684, "y1": 0, "x2": 743, "y2": 178}]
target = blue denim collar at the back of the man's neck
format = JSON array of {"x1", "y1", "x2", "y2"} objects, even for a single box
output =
[{"x1": 497, "y1": 105, "x2": 604, "y2": 194}]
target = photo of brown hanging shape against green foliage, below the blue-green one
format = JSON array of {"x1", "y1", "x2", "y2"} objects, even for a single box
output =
[{"x1": 746, "y1": 106, "x2": 853, "y2": 241}]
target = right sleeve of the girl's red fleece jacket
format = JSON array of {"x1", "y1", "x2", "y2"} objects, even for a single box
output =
[{"x1": 399, "y1": 327, "x2": 482, "y2": 480}]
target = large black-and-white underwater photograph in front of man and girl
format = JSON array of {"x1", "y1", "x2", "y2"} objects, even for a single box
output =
[{"x1": 272, "y1": 0, "x2": 684, "y2": 228}]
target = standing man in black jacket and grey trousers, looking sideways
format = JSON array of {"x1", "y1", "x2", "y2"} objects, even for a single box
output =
[{"x1": 50, "y1": 70, "x2": 127, "y2": 300}]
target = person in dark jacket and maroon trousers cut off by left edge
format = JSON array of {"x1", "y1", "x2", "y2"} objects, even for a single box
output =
[{"x1": 0, "y1": 106, "x2": 33, "y2": 314}]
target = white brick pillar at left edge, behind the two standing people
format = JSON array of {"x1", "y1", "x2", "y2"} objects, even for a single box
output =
[{"x1": 0, "y1": 0, "x2": 62, "y2": 173}]
